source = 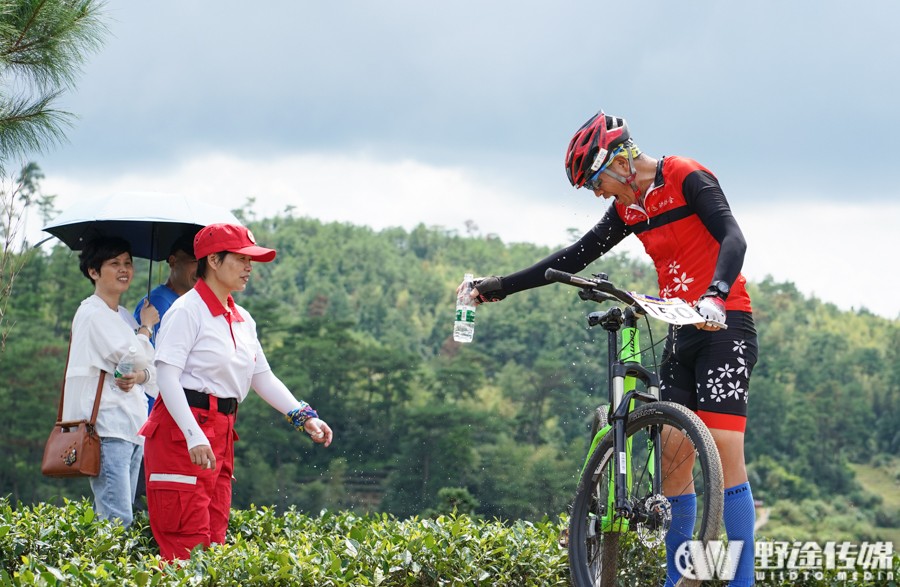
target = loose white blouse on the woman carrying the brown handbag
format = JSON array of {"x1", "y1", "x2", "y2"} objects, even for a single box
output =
[{"x1": 63, "y1": 295, "x2": 157, "y2": 444}]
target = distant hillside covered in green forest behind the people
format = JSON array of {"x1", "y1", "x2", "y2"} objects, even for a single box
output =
[{"x1": 0, "y1": 217, "x2": 900, "y2": 539}]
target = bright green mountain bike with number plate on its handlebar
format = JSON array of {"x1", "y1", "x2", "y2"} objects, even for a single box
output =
[{"x1": 545, "y1": 269, "x2": 724, "y2": 587}]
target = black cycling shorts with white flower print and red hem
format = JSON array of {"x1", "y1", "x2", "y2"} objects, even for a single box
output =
[{"x1": 660, "y1": 311, "x2": 759, "y2": 432}]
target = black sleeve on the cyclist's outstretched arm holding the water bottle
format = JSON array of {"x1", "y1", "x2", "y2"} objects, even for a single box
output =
[{"x1": 501, "y1": 205, "x2": 631, "y2": 295}]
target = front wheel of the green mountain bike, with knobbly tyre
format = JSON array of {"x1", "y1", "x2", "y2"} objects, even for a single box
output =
[{"x1": 568, "y1": 402, "x2": 724, "y2": 587}]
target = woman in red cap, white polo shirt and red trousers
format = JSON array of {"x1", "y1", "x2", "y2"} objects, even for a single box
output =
[{"x1": 141, "y1": 224, "x2": 332, "y2": 560}]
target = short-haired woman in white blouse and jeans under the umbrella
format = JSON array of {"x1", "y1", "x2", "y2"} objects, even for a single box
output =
[{"x1": 63, "y1": 237, "x2": 159, "y2": 526}]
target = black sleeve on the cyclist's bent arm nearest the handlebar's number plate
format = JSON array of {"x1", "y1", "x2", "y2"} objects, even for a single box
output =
[{"x1": 681, "y1": 171, "x2": 747, "y2": 285}]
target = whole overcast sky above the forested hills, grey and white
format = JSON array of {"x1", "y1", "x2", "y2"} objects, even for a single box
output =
[{"x1": 24, "y1": 0, "x2": 900, "y2": 318}]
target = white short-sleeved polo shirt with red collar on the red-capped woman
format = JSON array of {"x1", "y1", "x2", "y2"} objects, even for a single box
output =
[{"x1": 156, "y1": 279, "x2": 271, "y2": 401}]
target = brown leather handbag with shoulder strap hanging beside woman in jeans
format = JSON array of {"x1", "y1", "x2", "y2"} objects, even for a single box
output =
[{"x1": 41, "y1": 339, "x2": 106, "y2": 477}]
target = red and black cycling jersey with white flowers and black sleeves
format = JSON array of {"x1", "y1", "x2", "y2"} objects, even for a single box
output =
[{"x1": 501, "y1": 157, "x2": 751, "y2": 312}]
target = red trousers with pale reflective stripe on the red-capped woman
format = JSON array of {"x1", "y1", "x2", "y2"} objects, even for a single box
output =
[{"x1": 140, "y1": 396, "x2": 237, "y2": 560}]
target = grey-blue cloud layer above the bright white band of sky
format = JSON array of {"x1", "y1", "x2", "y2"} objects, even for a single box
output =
[{"x1": 38, "y1": 0, "x2": 900, "y2": 203}]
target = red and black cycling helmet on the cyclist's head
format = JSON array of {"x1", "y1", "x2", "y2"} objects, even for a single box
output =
[{"x1": 566, "y1": 110, "x2": 631, "y2": 188}]
